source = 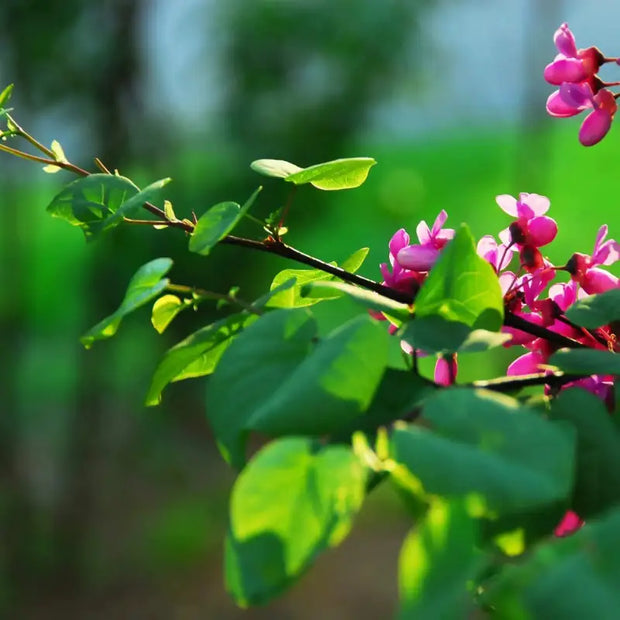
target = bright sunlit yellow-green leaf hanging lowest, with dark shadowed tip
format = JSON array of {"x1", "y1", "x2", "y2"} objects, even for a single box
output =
[{"x1": 225, "y1": 437, "x2": 366, "y2": 607}]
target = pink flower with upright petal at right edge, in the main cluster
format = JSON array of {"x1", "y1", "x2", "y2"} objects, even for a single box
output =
[{"x1": 565, "y1": 224, "x2": 620, "y2": 295}]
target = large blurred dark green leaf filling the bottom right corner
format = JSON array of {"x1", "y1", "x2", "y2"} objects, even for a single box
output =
[{"x1": 484, "y1": 509, "x2": 620, "y2": 620}]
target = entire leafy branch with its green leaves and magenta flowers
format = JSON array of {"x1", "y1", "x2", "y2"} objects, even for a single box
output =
[{"x1": 0, "y1": 17, "x2": 620, "y2": 618}]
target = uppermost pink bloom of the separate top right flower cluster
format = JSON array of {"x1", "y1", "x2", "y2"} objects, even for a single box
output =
[{"x1": 544, "y1": 23, "x2": 604, "y2": 86}]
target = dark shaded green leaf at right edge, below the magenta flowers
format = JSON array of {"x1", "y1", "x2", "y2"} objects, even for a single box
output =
[{"x1": 550, "y1": 388, "x2": 620, "y2": 520}]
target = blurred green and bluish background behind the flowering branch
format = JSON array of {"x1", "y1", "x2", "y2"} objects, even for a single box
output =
[{"x1": 0, "y1": 0, "x2": 620, "y2": 619}]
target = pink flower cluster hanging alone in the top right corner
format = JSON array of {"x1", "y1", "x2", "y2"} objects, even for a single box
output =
[{"x1": 544, "y1": 24, "x2": 618, "y2": 146}]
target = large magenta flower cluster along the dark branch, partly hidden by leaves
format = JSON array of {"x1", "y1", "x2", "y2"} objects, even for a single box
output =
[{"x1": 378, "y1": 193, "x2": 620, "y2": 536}]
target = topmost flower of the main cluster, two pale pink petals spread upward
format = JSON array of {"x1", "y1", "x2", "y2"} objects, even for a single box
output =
[{"x1": 495, "y1": 192, "x2": 558, "y2": 250}]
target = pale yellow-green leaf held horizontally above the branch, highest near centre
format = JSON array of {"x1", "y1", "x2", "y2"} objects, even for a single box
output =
[{"x1": 250, "y1": 157, "x2": 377, "y2": 190}]
